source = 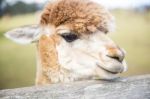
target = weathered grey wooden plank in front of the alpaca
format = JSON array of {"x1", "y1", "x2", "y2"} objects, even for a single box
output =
[{"x1": 0, "y1": 75, "x2": 150, "y2": 99}]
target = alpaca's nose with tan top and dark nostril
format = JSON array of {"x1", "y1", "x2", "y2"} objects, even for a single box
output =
[{"x1": 106, "y1": 47, "x2": 125, "y2": 62}]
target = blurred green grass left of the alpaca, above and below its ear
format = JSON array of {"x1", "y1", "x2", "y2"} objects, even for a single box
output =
[{"x1": 0, "y1": 14, "x2": 36, "y2": 89}]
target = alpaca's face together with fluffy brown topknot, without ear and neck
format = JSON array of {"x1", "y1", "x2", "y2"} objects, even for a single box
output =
[{"x1": 38, "y1": 0, "x2": 126, "y2": 79}]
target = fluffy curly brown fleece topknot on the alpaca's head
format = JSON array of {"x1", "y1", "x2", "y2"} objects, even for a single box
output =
[{"x1": 40, "y1": 0, "x2": 112, "y2": 34}]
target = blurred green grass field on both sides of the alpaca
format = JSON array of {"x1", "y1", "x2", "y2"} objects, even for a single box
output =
[{"x1": 0, "y1": 11, "x2": 150, "y2": 89}]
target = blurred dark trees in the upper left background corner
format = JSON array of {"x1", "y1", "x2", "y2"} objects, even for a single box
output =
[{"x1": 0, "y1": 0, "x2": 44, "y2": 17}]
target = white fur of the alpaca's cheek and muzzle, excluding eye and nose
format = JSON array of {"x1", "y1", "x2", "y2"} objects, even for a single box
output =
[{"x1": 57, "y1": 33, "x2": 126, "y2": 79}]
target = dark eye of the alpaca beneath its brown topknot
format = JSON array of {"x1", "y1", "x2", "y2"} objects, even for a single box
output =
[{"x1": 61, "y1": 33, "x2": 78, "y2": 42}]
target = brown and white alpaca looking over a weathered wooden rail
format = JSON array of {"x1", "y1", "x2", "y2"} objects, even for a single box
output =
[{"x1": 5, "y1": 0, "x2": 127, "y2": 85}]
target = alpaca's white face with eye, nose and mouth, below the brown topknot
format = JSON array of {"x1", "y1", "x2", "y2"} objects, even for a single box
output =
[{"x1": 41, "y1": 26, "x2": 127, "y2": 79}]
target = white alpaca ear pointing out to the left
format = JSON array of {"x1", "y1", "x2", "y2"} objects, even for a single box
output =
[{"x1": 5, "y1": 25, "x2": 40, "y2": 44}]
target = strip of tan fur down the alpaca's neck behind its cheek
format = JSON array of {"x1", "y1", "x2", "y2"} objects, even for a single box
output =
[{"x1": 37, "y1": 35, "x2": 60, "y2": 84}]
